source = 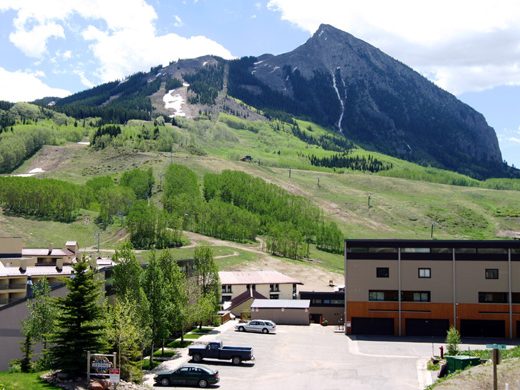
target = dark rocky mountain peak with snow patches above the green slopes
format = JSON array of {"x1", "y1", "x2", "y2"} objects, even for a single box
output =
[{"x1": 42, "y1": 24, "x2": 508, "y2": 178}]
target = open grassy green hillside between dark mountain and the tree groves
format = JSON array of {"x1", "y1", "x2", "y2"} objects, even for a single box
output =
[{"x1": 2, "y1": 109, "x2": 520, "y2": 248}]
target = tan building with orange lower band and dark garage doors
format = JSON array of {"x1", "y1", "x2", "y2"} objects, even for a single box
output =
[{"x1": 345, "y1": 240, "x2": 520, "y2": 338}]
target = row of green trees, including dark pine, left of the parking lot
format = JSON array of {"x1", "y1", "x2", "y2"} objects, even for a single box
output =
[{"x1": 19, "y1": 243, "x2": 220, "y2": 382}]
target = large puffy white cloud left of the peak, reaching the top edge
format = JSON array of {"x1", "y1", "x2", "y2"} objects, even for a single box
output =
[{"x1": 0, "y1": 0, "x2": 232, "y2": 81}]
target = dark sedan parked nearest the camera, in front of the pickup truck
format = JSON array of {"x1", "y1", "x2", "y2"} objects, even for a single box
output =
[{"x1": 154, "y1": 364, "x2": 220, "y2": 387}]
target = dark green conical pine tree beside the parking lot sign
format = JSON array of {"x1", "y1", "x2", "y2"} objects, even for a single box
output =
[{"x1": 51, "y1": 257, "x2": 105, "y2": 375}]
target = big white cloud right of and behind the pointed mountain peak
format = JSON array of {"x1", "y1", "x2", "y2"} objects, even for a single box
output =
[{"x1": 267, "y1": 0, "x2": 520, "y2": 93}]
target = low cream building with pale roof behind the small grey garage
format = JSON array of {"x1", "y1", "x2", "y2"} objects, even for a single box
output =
[{"x1": 219, "y1": 271, "x2": 303, "y2": 316}]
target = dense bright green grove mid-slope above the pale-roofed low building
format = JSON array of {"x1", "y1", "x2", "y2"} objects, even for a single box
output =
[{"x1": 163, "y1": 165, "x2": 343, "y2": 258}]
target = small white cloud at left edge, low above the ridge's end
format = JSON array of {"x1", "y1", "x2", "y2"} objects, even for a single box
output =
[{"x1": 0, "y1": 67, "x2": 70, "y2": 102}]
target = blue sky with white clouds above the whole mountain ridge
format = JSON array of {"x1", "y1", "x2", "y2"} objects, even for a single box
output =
[{"x1": 0, "y1": 0, "x2": 520, "y2": 167}]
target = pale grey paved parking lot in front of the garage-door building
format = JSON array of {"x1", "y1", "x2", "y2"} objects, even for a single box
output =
[{"x1": 149, "y1": 324, "x2": 431, "y2": 390}]
